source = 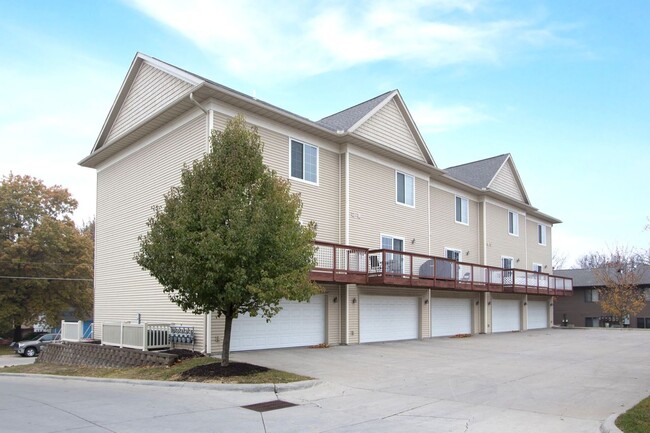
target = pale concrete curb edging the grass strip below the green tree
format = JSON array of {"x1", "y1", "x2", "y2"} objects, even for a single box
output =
[{"x1": 0, "y1": 373, "x2": 322, "y2": 393}]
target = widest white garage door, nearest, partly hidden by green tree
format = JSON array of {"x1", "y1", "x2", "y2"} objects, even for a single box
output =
[{"x1": 230, "y1": 295, "x2": 326, "y2": 351}]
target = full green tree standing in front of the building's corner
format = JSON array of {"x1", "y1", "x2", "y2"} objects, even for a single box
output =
[{"x1": 135, "y1": 116, "x2": 320, "y2": 366}]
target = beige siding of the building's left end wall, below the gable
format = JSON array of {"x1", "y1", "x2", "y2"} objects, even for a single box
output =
[{"x1": 94, "y1": 115, "x2": 206, "y2": 350}]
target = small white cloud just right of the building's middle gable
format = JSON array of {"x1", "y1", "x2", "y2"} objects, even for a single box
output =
[{"x1": 410, "y1": 103, "x2": 494, "y2": 133}]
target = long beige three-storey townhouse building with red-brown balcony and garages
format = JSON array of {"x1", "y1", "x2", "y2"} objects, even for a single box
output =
[{"x1": 80, "y1": 54, "x2": 571, "y2": 352}]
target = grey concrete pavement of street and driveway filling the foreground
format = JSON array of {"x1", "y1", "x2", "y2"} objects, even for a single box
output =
[{"x1": 0, "y1": 329, "x2": 650, "y2": 433}]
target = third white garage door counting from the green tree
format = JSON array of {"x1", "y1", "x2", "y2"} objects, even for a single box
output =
[{"x1": 431, "y1": 298, "x2": 472, "y2": 337}]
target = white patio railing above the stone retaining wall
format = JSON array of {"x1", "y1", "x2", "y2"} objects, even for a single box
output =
[{"x1": 102, "y1": 322, "x2": 170, "y2": 350}]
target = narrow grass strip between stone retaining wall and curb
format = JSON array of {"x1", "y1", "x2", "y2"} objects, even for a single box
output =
[{"x1": 0, "y1": 357, "x2": 311, "y2": 383}]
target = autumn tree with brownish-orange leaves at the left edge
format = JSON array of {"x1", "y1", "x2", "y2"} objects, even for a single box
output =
[{"x1": 0, "y1": 173, "x2": 94, "y2": 340}]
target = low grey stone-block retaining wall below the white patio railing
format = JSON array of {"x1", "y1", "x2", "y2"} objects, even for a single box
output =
[{"x1": 36, "y1": 341, "x2": 177, "y2": 368}]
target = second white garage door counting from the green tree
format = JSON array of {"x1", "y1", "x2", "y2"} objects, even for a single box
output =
[{"x1": 359, "y1": 295, "x2": 420, "y2": 343}]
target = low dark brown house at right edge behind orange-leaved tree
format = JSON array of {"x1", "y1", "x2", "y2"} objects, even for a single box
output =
[{"x1": 554, "y1": 266, "x2": 650, "y2": 328}]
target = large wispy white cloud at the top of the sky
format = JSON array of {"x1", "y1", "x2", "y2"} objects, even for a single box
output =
[{"x1": 126, "y1": 0, "x2": 555, "y2": 81}]
